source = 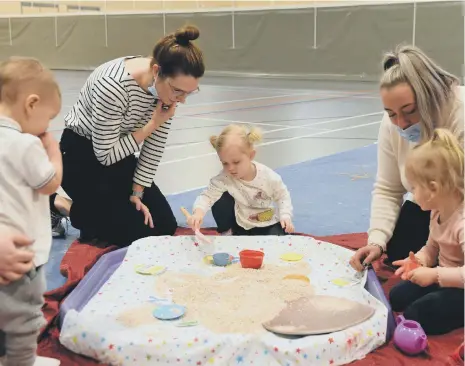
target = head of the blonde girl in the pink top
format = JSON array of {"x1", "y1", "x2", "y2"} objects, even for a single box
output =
[{"x1": 405, "y1": 128, "x2": 464, "y2": 199}]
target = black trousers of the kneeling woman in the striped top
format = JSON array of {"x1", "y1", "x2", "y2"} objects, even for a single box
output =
[{"x1": 54, "y1": 129, "x2": 177, "y2": 246}]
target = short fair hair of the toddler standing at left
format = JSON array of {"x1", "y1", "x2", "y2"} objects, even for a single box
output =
[{"x1": 0, "y1": 57, "x2": 61, "y2": 104}]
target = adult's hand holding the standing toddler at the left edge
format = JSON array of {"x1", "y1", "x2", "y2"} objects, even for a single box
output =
[{"x1": 0, "y1": 230, "x2": 34, "y2": 285}]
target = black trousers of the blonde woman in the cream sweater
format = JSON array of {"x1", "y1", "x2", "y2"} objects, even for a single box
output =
[{"x1": 386, "y1": 201, "x2": 431, "y2": 262}]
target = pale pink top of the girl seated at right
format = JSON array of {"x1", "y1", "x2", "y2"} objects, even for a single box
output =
[{"x1": 415, "y1": 203, "x2": 465, "y2": 288}]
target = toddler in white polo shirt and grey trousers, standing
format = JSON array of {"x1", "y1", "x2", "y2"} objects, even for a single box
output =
[{"x1": 0, "y1": 58, "x2": 62, "y2": 366}]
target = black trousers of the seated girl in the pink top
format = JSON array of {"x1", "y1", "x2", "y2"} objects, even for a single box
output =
[{"x1": 389, "y1": 281, "x2": 464, "y2": 334}]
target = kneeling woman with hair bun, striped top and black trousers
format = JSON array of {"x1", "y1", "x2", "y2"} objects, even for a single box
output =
[{"x1": 51, "y1": 26, "x2": 205, "y2": 246}]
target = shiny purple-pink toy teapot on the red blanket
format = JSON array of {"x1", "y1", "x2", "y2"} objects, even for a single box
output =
[{"x1": 394, "y1": 315, "x2": 428, "y2": 356}]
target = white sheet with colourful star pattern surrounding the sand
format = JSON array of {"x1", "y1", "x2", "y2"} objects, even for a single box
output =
[{"x1": 60, "y1": 236, "x2": 387, "y2": 366}]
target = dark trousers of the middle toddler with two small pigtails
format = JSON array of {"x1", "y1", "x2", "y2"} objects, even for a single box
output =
[{"x1": 212, "y1": 192, "x2": 286, "y2": 236}]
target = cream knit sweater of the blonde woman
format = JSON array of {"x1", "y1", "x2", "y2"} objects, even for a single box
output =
[{"x1": 368, "y1": 87, "x2": 465, "y2": 249}]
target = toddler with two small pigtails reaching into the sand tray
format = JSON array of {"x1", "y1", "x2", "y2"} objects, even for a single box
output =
[{"x1": 188, "y1": 125, "x2": 294, "y2": 235}]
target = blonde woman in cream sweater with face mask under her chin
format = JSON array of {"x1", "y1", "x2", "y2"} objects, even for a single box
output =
[{"x1": 350, "y1": 46, "x2": 464, "y2": 271}]
